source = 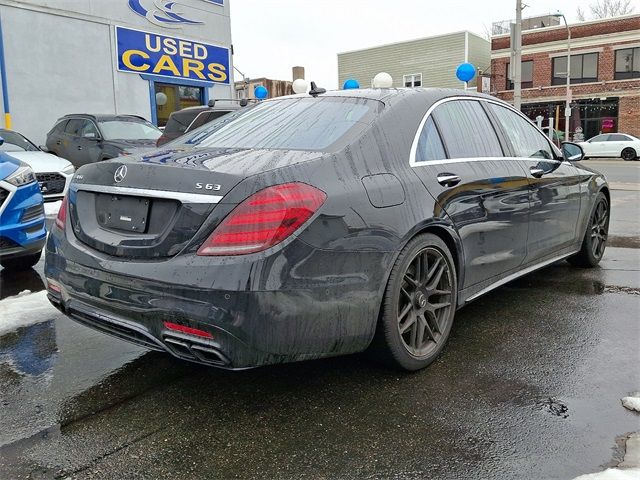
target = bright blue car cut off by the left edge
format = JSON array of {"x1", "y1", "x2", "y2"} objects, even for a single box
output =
[{"x1": 0, "y1": 150, "x2": 47, "y2": 270}]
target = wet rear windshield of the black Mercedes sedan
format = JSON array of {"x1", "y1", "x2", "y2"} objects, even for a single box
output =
[{"x1": 177, "y1": 97, "x2": 382, "y2": 151}]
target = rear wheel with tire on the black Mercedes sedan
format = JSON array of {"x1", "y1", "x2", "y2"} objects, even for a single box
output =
[{"x1": 374, "y1": 233, "x2": 458, "y2": 371}]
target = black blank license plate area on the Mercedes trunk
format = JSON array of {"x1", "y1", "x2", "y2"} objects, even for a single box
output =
[{"x1": 96, "y1": 195, "x2": 151, "y2": 233}]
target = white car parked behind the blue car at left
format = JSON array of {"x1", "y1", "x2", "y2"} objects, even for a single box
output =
[{"x1": 0, "y1": 129, "x2": 75, "y2": 202}]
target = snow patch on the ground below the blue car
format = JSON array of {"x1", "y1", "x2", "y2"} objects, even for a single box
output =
[{"x1": 0, "y1": 290, "x2": 58, "y2": 335}]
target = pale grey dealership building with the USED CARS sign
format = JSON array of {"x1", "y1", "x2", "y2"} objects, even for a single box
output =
[{"x1": 0, "y1": 0, "x2": 235, "y2": 143}]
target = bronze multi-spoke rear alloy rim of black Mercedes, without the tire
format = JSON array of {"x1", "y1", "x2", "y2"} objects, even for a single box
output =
[{"x1": 397, "y1": 247, "x2": 453, "y2": 358}]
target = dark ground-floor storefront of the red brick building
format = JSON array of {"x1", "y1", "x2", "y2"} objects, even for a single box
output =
[{"x1": 522, "y1": 97, "x2": 620, "y2": 140}]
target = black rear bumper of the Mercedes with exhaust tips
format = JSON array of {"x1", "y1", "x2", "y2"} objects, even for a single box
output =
[{"x1": 45, "y1": 229, "x2": 386, "y2": 369}]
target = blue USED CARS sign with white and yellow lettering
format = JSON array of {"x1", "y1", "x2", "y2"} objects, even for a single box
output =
[{"x1": 116, "y1": 27, "x2": 229, "y2": 83}]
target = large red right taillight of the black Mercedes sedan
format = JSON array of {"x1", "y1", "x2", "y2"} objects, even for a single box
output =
[{"x1": 198, "y1": 183, "x2": 327, "y2": 255}]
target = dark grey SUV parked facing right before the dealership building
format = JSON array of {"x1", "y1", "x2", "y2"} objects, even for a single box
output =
[{"x1": 47, "y1": 114, "x2": 162, "y2": 168}]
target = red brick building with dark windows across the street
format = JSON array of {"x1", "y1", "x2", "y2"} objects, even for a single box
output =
[{"x1": 491, "y1": 15, "x2": 640, "y2": 139}]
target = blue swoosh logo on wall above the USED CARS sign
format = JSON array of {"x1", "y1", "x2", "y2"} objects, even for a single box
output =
[{"x1": 129, "y1": 0, "x2": 224, "y2": 27}]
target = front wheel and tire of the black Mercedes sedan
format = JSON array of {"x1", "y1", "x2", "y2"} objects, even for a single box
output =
[{"x1": 567, "y1": 192, "x2": 610, "y2": 268}]
